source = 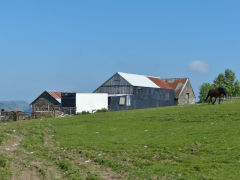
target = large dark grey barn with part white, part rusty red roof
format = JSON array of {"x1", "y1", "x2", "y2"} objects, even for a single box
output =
[{"x1": 94, "y1": 72, "x2": 176, "y2": 111}]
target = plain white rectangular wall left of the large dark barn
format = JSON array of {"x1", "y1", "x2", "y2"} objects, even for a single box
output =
[{"x1": 76, "y1": 93, "x2": 108, "y2": 113}]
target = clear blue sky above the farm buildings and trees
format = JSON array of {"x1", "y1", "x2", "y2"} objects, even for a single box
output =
[{"x1": 0, "y1": 0, "x2": 240, "y2": 102}]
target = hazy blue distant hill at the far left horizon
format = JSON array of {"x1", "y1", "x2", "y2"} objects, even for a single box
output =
[{"x1": 0, "y1": 101, "x2": 31, "y2": 112}]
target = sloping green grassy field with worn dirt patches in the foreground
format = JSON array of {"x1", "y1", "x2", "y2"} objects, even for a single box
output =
[{"x1": 0, "y1": 101, "x2": 240, "y2": 180}]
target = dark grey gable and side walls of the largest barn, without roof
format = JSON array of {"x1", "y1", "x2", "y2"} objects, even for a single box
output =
[{"x1": 94, "y1": 73, "x2": 176, "y2": 111}]
